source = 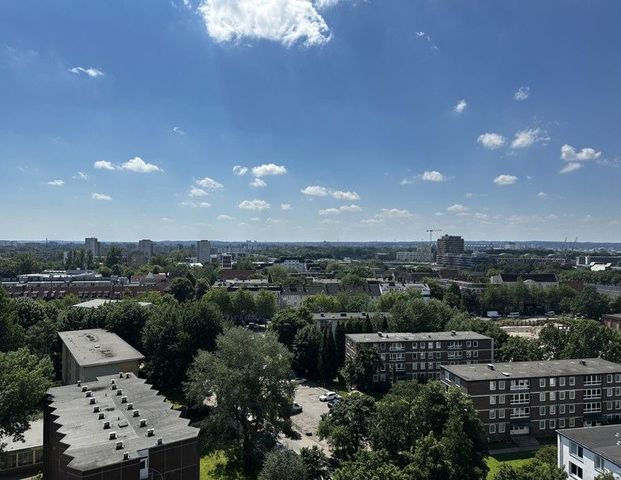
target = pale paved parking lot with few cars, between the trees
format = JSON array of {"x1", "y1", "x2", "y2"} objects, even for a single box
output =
[{"x1": 282, "y1": 385, "x2": 330, "y2": 455}]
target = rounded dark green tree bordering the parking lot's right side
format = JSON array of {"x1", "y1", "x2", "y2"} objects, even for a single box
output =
[{"x1": 317, "y1": 392, "x2": 375, "y2": 460}]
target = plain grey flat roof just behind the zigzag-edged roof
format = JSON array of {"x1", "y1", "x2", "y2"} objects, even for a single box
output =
[{"x1": 58, "y1": 328, "x2": 144, "y2": 367}]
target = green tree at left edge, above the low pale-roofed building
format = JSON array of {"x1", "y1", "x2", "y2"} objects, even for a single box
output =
[{"x1": 0, "y1": 348, "x2": 54, "y2": 446}]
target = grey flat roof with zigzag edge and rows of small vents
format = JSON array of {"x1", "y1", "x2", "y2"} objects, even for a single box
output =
[{"x1": 47, "y1": 373, "x2": 199, "y2": 471}]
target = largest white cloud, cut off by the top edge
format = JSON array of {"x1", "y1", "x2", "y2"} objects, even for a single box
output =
[{"x1": 198, "y1": 0, "x2": 337, "y2": 47}]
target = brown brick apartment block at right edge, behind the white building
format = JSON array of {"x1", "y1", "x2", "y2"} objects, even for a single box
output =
[{"x1": 442, "y1": 358, "x2": 621, "y2": 439}]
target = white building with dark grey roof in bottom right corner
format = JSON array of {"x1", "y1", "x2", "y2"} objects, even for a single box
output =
[{"x1": 556, "y1": 425, "x2": 621, "y2": 480}]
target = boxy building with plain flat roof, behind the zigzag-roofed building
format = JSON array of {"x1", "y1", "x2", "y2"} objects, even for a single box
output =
[{"x1": 58, "y1": 328, "x2": 144, "y2": 385}]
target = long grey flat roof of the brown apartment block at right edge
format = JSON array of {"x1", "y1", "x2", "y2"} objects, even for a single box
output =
[{"x1": 442, "y1": 358, "x2": 621, "y2": 381}]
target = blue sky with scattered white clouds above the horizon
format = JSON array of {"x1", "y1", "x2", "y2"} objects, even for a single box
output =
[{"x1": 0, "y1": 0, "x2": 621, "y2": 241}]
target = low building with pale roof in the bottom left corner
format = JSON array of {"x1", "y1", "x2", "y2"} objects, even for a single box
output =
[{"x1": 0, "y1": 420, "x2": 43, "y2": 478}]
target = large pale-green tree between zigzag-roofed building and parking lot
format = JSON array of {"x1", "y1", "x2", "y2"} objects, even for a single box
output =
[{"x1": 185, "y1": 327, "x2": 294, "y2": 467}]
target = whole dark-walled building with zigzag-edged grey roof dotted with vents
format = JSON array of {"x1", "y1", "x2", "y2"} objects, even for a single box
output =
[{"x1": 43, "y1": 373, "x2": 200, "y2": 480}]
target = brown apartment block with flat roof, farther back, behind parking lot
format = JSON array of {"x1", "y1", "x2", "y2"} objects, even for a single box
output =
[{"x1": 345, "y1": 331, "x2": 494, "y2": 382}]
